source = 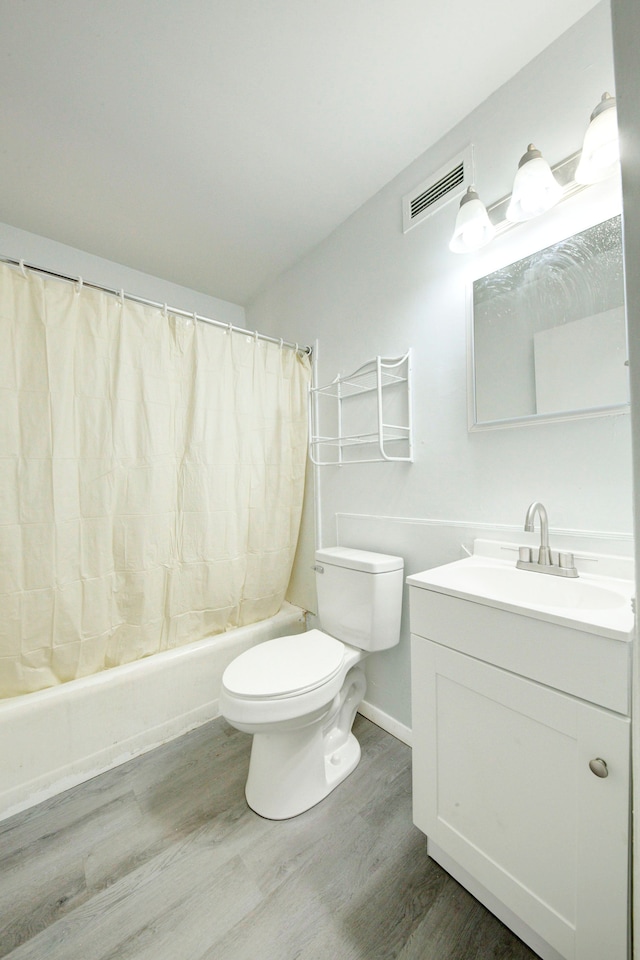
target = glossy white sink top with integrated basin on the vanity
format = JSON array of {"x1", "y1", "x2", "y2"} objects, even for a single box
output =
[{"x1": 408, "y1": 541, "x2": 634, "y2": 638}]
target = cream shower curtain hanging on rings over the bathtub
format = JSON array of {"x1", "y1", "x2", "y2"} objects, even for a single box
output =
[{"x1": 0, "y1": 265, "x2": 310, "y2": 697}]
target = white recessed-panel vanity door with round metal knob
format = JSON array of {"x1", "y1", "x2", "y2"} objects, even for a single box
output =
[{"x1": 412, "y1": 636, "x2": 629, "y2": 960}]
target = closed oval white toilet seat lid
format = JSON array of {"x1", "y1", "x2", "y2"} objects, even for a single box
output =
[{"x1": 222, "y1": 630, "x2": 344, "y2": 699}]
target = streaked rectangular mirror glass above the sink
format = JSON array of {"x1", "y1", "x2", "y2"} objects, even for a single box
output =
[{"x1": 471, "y1": 216, "x2": 629, "y2": 426}]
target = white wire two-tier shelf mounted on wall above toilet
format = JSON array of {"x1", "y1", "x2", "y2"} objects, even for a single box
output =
[{"x1": 309, "y1": 350, "x2": 413, "y2": 466}]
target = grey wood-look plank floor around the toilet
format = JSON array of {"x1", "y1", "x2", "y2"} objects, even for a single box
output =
[{"x1": 0, "y1": 717, "x2": 535, "y2": 960}]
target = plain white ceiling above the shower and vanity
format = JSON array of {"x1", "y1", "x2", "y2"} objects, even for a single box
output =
[{"x1": 0, "y1": 0, "x2": 596, "y2": 304}]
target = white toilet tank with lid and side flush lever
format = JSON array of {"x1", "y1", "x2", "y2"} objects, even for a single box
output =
[{"x1": 315, "y1": 547, "x2": 404, "y2": 651}]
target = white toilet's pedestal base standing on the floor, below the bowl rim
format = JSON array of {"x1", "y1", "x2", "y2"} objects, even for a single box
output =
[{"x1": 245, "y1": 667, "x2": 366, "y2": 820}]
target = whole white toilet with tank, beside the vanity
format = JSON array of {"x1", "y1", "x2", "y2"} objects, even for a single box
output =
[{"x1": 220, "y1": 547, "x2": 403, "y2": 820}]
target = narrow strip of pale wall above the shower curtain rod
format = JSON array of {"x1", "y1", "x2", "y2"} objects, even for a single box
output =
[{"x1": 0, "y1": 223, "x2": 245, "y2": 327}]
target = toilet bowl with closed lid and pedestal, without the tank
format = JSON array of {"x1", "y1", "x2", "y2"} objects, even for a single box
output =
[{"x1": 220, "y1": 630, "x2": 366, "y2": 820}]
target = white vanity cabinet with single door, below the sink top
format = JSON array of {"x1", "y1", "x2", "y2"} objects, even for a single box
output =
[{"x1": 409, "y1": 574, "x2": 630, "y2": 960}]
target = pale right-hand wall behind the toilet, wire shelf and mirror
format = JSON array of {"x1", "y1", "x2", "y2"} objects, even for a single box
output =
[{"x1": 247, "y1": 3, "x2": 632, "y2": 725}]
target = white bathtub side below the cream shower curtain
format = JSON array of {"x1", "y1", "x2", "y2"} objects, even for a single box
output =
[{"x1": 0, "y1": 603, "x2": 305, "y2": 820}]
